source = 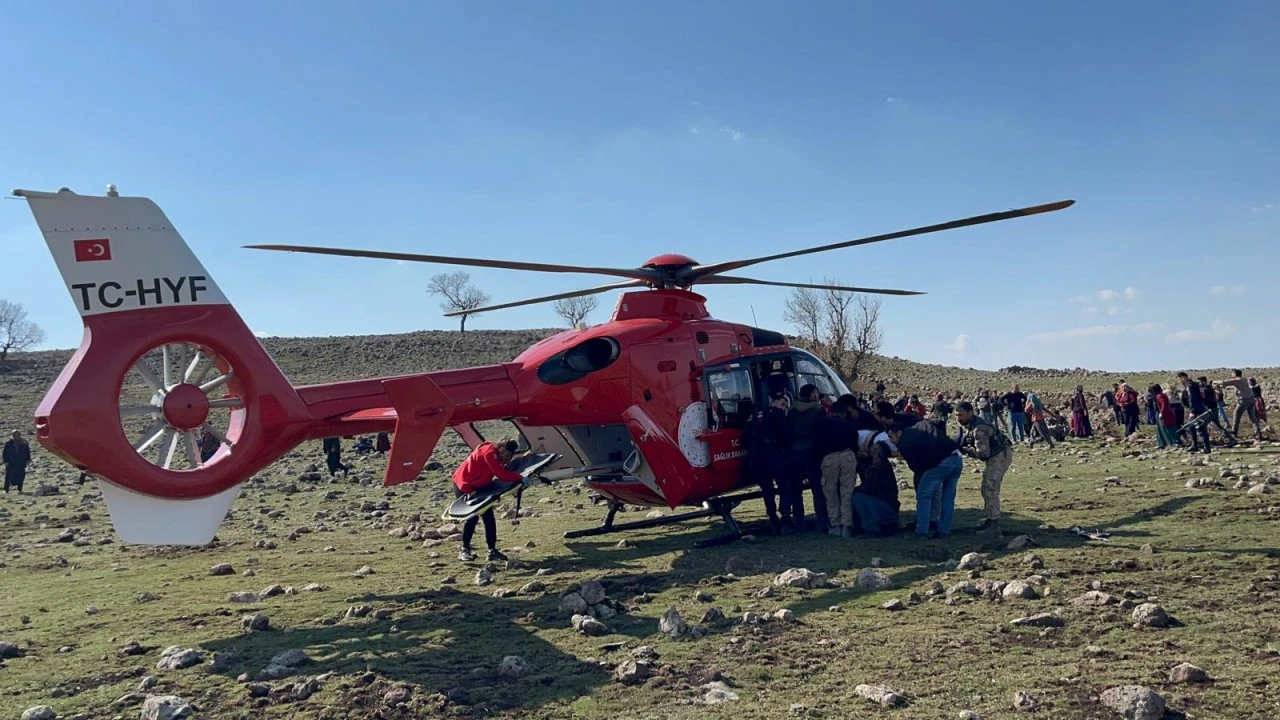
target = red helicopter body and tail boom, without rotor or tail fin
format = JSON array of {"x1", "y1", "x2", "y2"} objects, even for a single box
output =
[{"x1": 297, "y1": 283, "x2": 847, "y2": 507}]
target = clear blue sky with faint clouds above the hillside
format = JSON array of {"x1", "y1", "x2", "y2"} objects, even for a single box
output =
[{"x1": 0, "y1": 0, "x2": 1280, "y2": 369}]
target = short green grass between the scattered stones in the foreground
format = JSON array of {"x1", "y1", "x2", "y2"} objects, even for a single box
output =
[{"x1": 0, "y1": 443, "x2": 1280, "y2": 719}]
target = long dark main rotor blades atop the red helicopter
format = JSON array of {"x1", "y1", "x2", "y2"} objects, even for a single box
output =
[{"x1": 246, "y1": 200, "x2": 1075, "y2": 316}]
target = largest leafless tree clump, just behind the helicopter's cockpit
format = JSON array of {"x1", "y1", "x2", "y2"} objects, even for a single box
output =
[{"x1": 782, "y1": 278, "x2": 882, "y2": 383}]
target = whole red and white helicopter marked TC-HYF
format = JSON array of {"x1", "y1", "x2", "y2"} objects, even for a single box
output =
[{"x1": 13, "y1": 186, "x2": 1074, "y2": 546}]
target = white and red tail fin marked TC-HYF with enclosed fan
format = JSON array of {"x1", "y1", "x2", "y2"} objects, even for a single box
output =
[{"x1": 14, "y1": 188, "x2": 314, "y2": 544}]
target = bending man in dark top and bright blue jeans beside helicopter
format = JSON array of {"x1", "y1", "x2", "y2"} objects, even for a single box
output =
[{"x1": 887, "y1": 424, "x2": 964, "y2": 538}]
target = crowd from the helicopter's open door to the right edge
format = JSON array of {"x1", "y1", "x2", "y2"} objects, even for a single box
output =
[{"x1": 745, "y1": 370, "x2": 1267, "y2": 538}]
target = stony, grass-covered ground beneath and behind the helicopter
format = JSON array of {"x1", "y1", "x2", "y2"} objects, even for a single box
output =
[{"x1": 0, "y1": 332, "x2": 1280, "y2": 720}]
